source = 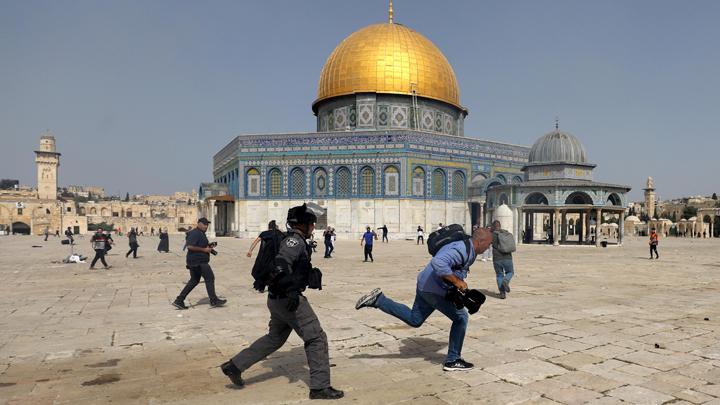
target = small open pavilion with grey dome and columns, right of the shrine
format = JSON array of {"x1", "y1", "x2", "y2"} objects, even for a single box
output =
[{"x1": 486, "y1": 125, "x2": 630, "y2": 246}]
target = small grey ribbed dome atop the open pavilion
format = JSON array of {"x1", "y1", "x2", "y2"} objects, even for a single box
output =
[{"x1": 528, "y1": 129, "x2": 587, "y2": 163}]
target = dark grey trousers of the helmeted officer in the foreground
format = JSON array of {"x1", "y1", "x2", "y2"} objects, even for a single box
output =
[{"x1": 232, "y1": 296, "x2": 330, "y2": 389}]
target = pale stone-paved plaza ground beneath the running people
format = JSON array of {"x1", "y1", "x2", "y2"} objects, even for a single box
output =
[{"x1": 0, "y1": 235, "x2": 720, "y2": 405}]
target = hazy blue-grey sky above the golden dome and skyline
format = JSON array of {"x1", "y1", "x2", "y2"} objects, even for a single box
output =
[{"x1": 0, "y1": 0, "x2": 720, "y2": 198}]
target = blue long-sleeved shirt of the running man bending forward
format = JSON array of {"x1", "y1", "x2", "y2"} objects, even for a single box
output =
[{"x1": 417, "y1": 240, "x2": 476, "y2": 296}]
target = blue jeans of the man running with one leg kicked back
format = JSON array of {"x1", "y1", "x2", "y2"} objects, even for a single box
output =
[{"x1": 375, "y1": 290, "x2": 468, "y2": 362}]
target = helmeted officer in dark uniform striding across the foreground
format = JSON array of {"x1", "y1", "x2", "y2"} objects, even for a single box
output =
[{"x1": 220, "y1": 204, "x2": 344, "y2": 399}]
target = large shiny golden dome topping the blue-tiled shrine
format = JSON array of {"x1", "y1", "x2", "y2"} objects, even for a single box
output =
[{"x1": 313, "y1": 23, "x2": 464, "y2": 110}]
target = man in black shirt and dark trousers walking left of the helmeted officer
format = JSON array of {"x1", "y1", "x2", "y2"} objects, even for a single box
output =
[{"x1": 172, "y1": 217, "x2": 227, "y2": 309}]
